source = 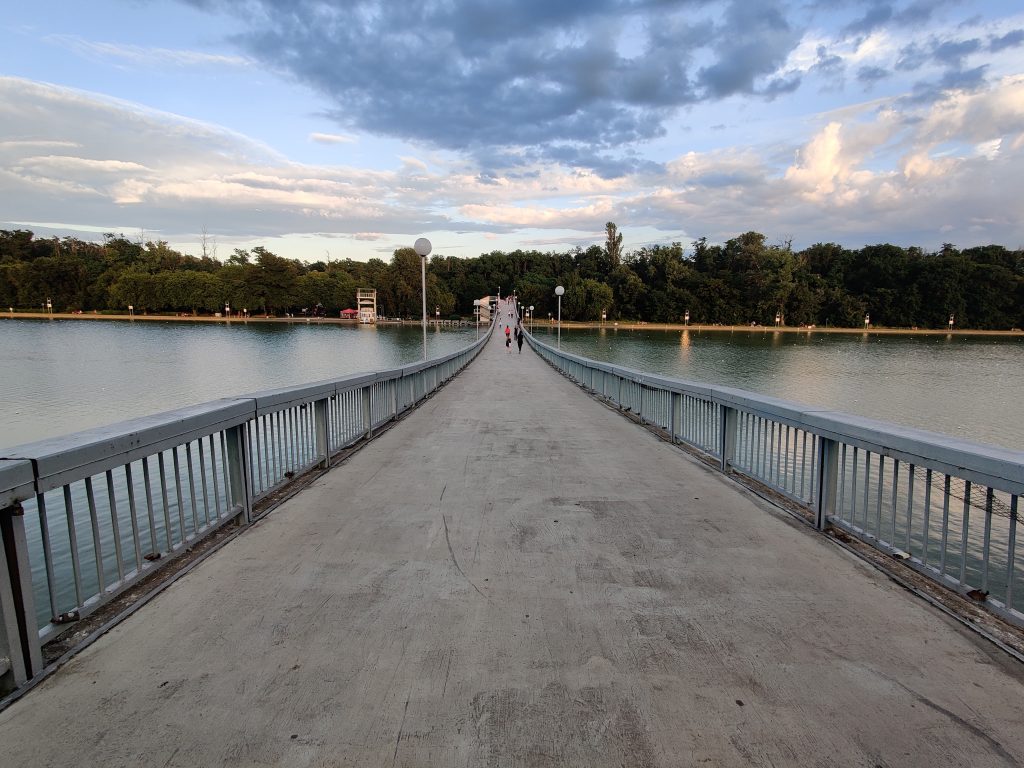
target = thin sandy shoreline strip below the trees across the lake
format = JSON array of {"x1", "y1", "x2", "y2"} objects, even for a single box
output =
[{"x1": 6, "y1": 312, "x2": 1024, "y2": 338}]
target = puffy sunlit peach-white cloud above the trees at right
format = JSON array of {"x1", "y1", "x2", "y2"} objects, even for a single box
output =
[{"x1": 647, "y1": 76, "x2": 1024, "y2": 247}]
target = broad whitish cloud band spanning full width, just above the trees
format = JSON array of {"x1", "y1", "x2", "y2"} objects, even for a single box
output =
[{"x1": 0, "y1": 68, "x2": 1024, "y2": 258}]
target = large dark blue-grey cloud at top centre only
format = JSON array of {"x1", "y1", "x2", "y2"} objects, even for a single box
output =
[{"x1": 174, "y1": 0, "x2": 815, "y2": 175}]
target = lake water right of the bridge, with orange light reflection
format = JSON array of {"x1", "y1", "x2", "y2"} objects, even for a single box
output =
[{"x1": 536, "y1": 326, "x2": 1024, "y2": 450}]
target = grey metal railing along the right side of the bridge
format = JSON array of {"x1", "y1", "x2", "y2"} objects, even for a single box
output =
[{"x1": 527, "y1": 335, "x2": 1024, "y2": 626}]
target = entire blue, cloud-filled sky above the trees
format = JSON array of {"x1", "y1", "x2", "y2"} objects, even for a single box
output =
[{"x1": 0, "y1": 0, "x2": 1024, "y2": 261}]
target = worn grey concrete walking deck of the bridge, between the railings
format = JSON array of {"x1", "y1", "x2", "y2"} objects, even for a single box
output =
[{"x1": 0, "y1": 327, "x2": 1024, "y2": 767}]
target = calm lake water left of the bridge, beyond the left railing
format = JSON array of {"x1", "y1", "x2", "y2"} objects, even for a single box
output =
[{"x1": 0, "y1": 319, "x2": 476, "y2": 449}]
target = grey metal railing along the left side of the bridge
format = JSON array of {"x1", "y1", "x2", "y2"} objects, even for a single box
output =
[{"x1": 0, "y1": 325, "x2": 489, "y2": 693}]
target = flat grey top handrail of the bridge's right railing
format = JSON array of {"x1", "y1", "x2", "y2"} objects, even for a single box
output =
[{"x1": 527, "y1": 333, "x2": 1024, "y2": 494}]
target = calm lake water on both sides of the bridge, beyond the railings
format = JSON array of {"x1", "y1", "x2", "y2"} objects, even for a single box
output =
[{"x1": 0, "y1": 319, "x2": 1024, "y2": 450}]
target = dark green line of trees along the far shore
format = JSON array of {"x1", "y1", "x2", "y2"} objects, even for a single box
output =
[{"x1": 0, "y1": 222, "x2": 1024, "y2": 330}]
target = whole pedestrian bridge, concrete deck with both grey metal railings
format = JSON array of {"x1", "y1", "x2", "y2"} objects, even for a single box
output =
[{"x1": 0, "y1": 321, "x2": 1024, "y2": 766}]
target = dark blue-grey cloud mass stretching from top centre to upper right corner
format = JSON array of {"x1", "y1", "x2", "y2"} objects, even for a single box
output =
[{"x1": 167, "y1": 0, "x2": 1017, "y2": 178}]
